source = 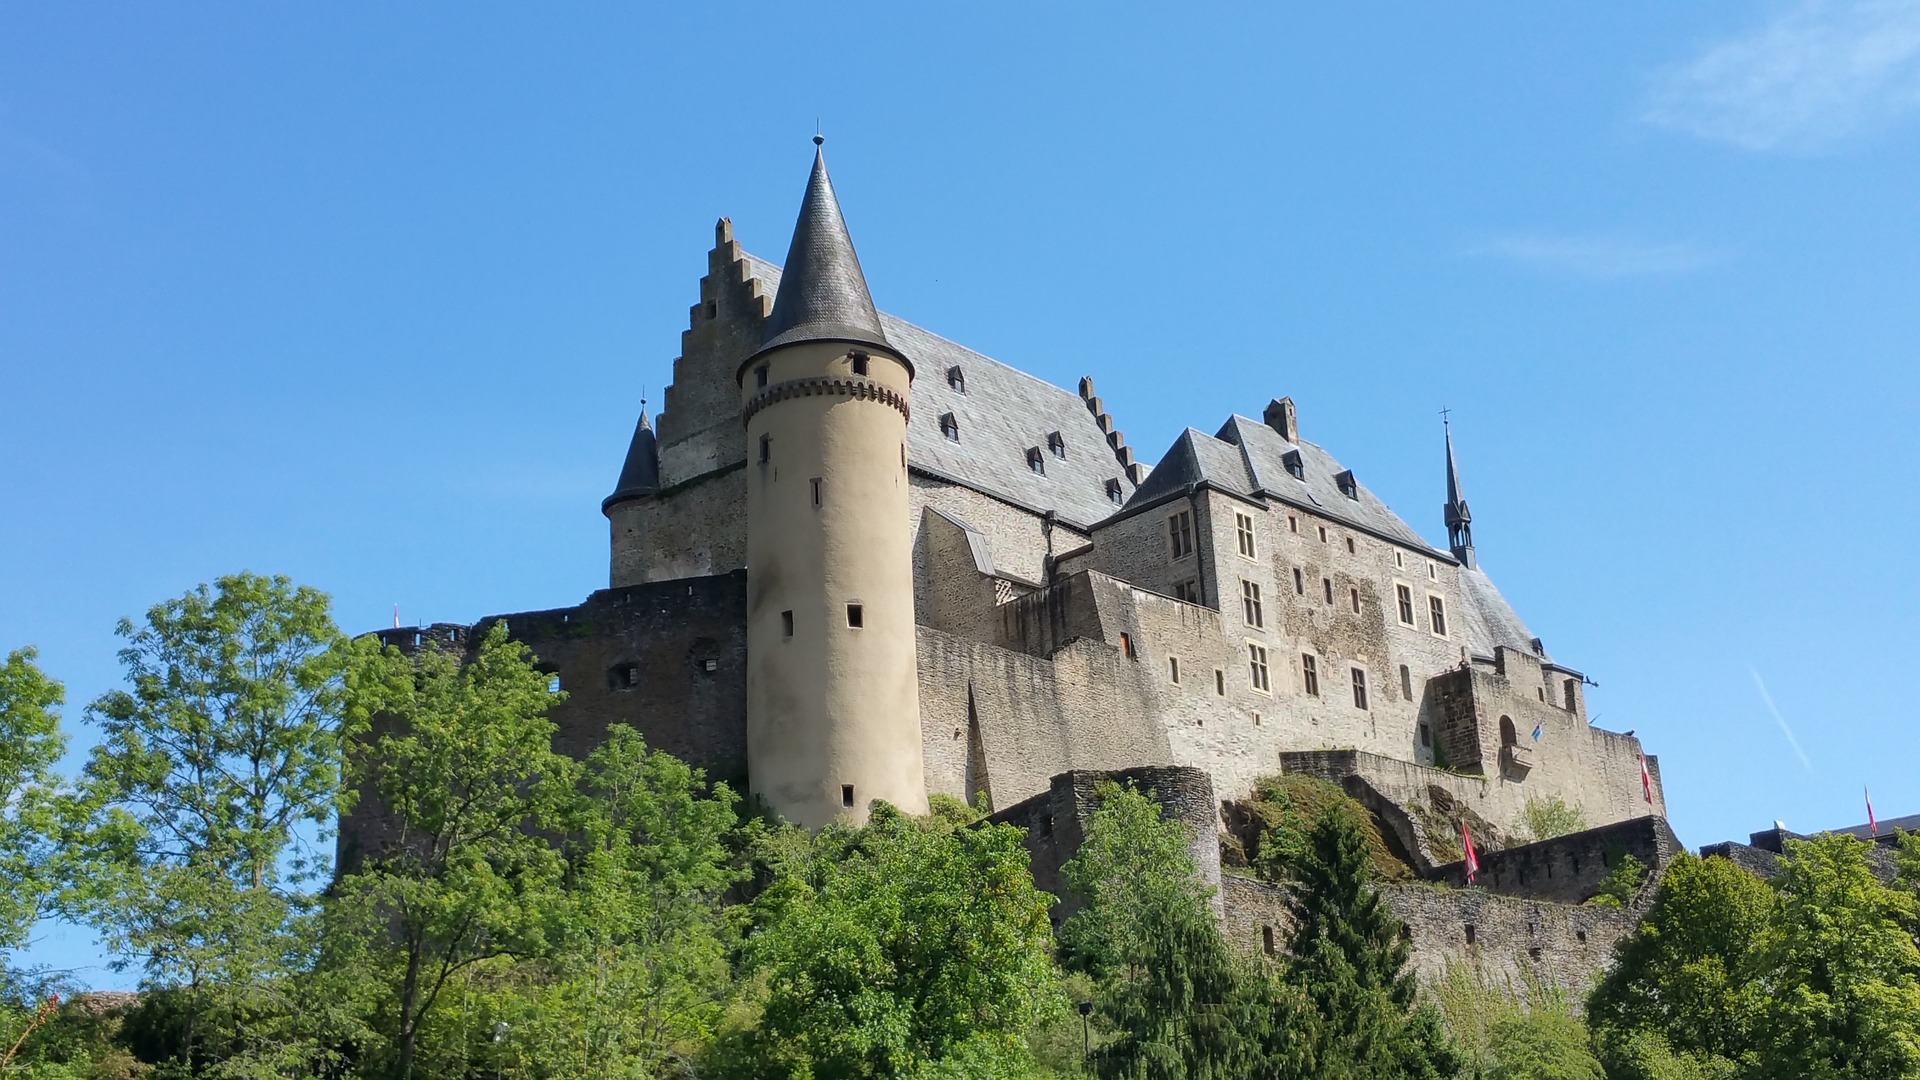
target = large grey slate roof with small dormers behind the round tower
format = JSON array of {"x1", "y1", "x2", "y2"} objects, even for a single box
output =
[{"x1": 745, "y1": 247, "x2": 1135, "y2": 530}]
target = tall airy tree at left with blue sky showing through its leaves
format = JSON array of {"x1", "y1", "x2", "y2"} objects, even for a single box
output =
[{"x1": 84, "y1": 573, "x2": 346, "y2": 1068}]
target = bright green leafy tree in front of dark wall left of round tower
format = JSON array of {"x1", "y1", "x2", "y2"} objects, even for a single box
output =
[{"x1": 328, "y1": 623, "x2": 574, "y2": 1076}]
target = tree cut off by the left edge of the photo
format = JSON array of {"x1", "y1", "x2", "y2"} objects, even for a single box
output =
[{"x1": 0, "y1": 648, "x2": 79, "y2": 949}]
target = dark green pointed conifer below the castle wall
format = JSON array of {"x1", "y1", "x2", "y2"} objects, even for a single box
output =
[{"x1": 1288, "y1": 809, "x2": 1459, "y2": 1078}]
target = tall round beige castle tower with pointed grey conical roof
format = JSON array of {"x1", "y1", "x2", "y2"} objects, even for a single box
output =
[{"x1": 735, "y1": 136, "x2": 927, "y2": 826}]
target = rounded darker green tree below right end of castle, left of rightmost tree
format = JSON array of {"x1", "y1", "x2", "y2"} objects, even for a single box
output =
[{"x1": 1588, "y1": 853, "x2": 1776, "y2": 1063}]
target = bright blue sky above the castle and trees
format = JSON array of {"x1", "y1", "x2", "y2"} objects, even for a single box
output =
[{"x1": 0, "y1": 2, "x2": 1920, "y2": 982}]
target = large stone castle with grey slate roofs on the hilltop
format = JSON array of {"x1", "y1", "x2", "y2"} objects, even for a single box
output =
[{"x1": 357, "y1": 138, "x2": 1678, "y2": 982}]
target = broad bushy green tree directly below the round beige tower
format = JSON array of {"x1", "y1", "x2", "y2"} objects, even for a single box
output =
[{"x1": 730, "y1": 803, "x2": 1060, "y2": 1080}]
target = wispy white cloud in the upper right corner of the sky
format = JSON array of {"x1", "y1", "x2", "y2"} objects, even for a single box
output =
[{"x1": 1642, "y1": 0, "x2": 1920, "y2": 152}]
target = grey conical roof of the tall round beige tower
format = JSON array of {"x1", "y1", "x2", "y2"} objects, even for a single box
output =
[{"x1": 760, "y1": 135, "x2": 893, "y2": 352}]
